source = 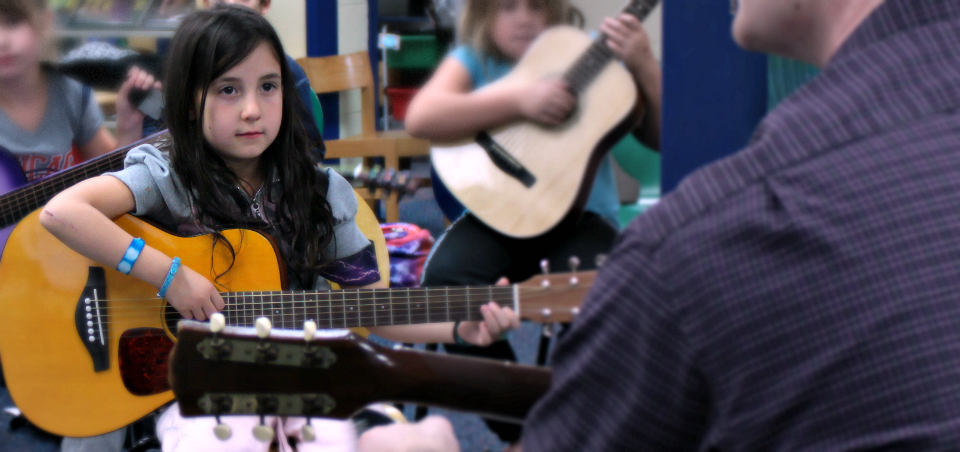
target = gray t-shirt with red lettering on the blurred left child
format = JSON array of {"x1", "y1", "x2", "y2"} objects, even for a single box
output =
[{"x1": 0, "y1": 70, "x2": 103, "y2": 181}]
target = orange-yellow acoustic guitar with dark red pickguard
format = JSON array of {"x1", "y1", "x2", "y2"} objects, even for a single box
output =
[{"x1": 0, "y1": 212, "x2": 594, "y2": 436}]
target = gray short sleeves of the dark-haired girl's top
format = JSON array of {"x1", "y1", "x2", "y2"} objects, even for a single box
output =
[{"x1": 106, "y1": 145, "x2": 379, "y2": 290}]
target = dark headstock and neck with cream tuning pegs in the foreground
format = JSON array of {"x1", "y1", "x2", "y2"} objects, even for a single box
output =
[{"x1": 170, "y1": 318, "x2": 551, "y2": 437}]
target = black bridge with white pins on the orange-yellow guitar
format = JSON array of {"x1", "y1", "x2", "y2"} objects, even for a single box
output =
[{"x1": 74, "y1": 267, "x2": 110, "y2": 372}]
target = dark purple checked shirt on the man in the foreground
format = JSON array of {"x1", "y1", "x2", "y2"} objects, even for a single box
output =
[{"x1": 524, "y1": 0, "x2": 960, "y2": 452}]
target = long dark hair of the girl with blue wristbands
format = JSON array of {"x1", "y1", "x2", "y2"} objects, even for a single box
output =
[{"x1": 164, "y1": 6, "x2": 334, "y2": 286}]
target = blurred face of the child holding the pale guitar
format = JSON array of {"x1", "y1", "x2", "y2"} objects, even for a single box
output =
[{"x1": 492, "y1": 0, "x2": 547, "y2": 61}]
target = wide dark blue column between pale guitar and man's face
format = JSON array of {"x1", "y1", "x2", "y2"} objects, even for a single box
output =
[{"x1": 661, "y1": 0, "x2": 767, "y2": 192}]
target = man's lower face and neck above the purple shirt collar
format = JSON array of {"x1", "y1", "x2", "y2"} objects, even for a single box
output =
[{"x1": 733, "y1": 0, "x2": 884, "y2": 66}]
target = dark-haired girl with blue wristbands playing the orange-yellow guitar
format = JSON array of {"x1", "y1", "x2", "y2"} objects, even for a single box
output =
[{"x1": 41, "y1": 6, "x2": 519, "y2": 451}]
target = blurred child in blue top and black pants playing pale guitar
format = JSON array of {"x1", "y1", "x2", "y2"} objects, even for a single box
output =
[{"x1": 406, "y1": 0, "x2": 660, "y2": 443}]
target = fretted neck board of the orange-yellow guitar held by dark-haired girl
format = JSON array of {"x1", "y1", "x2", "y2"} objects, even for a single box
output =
[{"x1": 221, "y1": 286, "x2": 515, "y2": 329}]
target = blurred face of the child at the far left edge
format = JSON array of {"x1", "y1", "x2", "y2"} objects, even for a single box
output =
[{"x1": 0, "y1": 15, "x2": 43, "y2": 80}]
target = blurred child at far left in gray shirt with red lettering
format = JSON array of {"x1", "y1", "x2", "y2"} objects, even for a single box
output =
[{"x1": 0, "y1": 0, "x2": 155, "y2": 181}]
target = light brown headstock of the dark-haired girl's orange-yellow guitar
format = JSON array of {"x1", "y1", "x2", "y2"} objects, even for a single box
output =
[{"x1": 517, "y1": 270, "x2": 597, "y2": 323}]
